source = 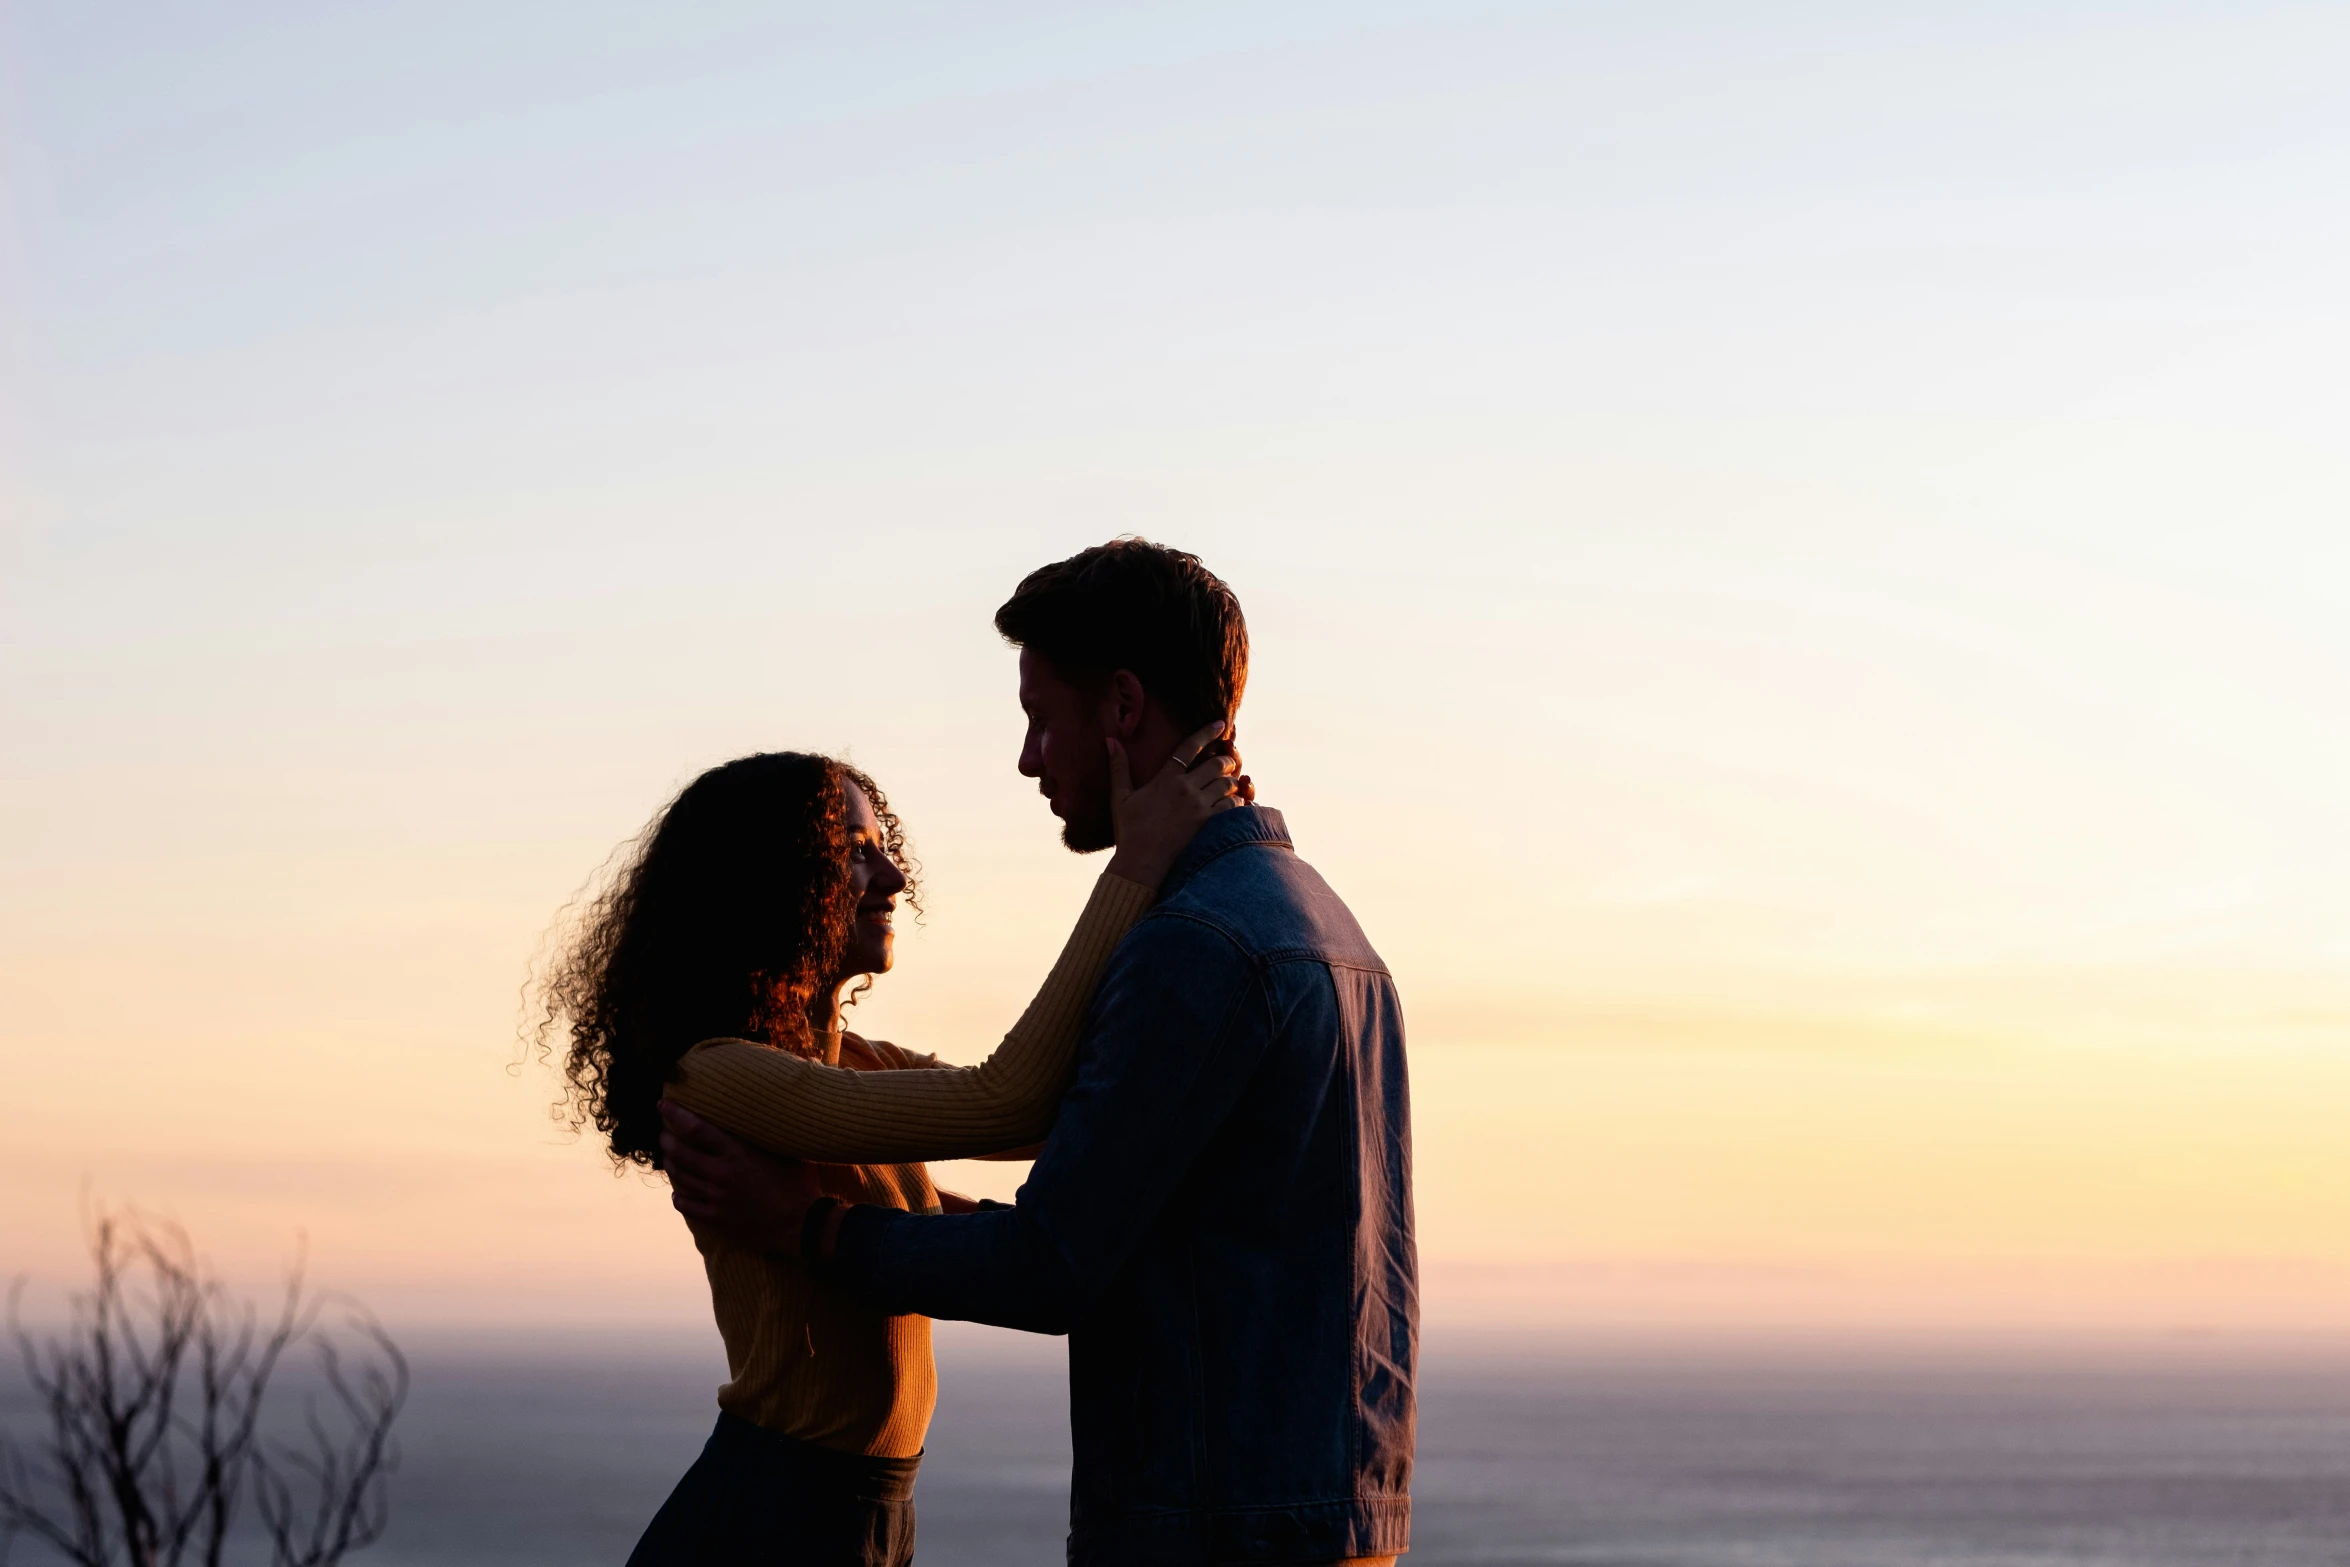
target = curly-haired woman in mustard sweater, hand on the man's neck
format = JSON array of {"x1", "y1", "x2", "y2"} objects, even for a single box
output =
[{"x1": 545, "y1": 724, "x2": 1246, "y2": 1567}]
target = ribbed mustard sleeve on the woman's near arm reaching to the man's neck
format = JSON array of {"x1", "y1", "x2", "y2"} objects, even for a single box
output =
[{"x1": 667, "y1": 872, "x2": 1154, "y2": 1165}]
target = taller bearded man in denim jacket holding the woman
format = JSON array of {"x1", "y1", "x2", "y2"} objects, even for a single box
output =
[{"x1": 665, "y1": 538, "x2": 1419, "y2": 1567}]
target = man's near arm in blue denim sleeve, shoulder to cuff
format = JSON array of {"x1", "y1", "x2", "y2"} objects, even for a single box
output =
[{"x1": 827, "y1": 914, "x2": 1274, "y2": 1332}]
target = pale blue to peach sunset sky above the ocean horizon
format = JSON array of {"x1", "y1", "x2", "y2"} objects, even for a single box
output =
[{"x1": 0, "y1": 0, "x2": 2350, "y2": 1332}]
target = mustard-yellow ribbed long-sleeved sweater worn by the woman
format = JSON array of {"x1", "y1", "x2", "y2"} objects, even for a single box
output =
[{"x1": 670, "y1": 872, "x2": 1154, "y2": 1459}]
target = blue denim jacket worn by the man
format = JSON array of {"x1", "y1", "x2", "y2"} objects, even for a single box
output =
[{"x1": 837, "y1": 806, "x2": 1419, "y2": 1567}]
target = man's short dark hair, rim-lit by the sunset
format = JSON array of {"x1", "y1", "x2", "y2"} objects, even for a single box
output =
[{"x1": 996, "y1": 538, "x2": 1248, "y2": 728}]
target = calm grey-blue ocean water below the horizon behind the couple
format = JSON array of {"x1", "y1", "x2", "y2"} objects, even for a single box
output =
[{"x1": 4, "y1": 1332, "x2": 2350, "y2": 1567}]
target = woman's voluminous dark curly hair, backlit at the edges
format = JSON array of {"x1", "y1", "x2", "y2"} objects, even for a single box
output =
[{"x1": 538, "y1": 752, "x2": 919, "y2": 1170}]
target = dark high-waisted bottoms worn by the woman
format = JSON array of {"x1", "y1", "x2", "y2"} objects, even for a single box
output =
[{"x1": 627, "y1": 1414, "x2": 921, "y2": 1567}]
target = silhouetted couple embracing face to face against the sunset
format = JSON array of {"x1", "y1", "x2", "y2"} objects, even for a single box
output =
[{"x1": 550, "y1": 538, "x2": 1419, "y2": 1567}]
